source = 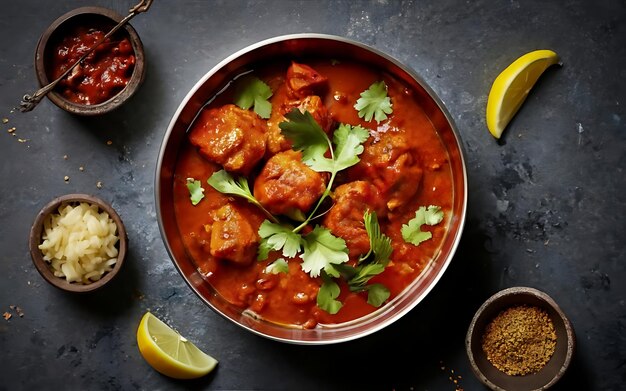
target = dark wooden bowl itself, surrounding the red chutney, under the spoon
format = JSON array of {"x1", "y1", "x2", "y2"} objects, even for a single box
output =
[{"x1": 35, "y1": 7, "x2": 146, "y2": 116}]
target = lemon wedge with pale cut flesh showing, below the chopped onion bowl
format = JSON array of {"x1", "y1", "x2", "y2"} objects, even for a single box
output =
[{"x1": 137, "y1": 311, "x2": 217, "y2": 379}]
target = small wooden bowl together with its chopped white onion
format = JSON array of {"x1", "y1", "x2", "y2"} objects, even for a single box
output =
[{"x1": 29, "y1": 194, "x2": 128, "y2": 293}]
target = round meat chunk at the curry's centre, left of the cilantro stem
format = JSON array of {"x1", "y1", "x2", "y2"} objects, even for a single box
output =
[{"x1": 254, "y1": 149, "x2": 326, "y2": 215}]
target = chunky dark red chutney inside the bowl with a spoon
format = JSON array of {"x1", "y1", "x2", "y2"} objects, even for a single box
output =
[{"x1": 49, "y1": 26, "x2": 135, "y2": 105}]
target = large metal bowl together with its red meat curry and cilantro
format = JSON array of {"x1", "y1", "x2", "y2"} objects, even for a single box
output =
[{"x1": 157, "y1": 36, "x2": 466, "y2": 343}]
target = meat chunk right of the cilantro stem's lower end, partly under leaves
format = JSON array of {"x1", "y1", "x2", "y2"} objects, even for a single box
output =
[{"x1": 323, "y1": 181, "x2": 385, "y2": 257}]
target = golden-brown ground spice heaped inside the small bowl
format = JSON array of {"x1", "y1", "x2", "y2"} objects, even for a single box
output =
[{"x1": 482, "y1": 305, "x2": 556, "y2": 376}]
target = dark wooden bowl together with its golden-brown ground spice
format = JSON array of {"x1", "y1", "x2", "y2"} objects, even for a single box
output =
[{"x1": 465, "y1": 287, "x2": 576, "y2": 391}]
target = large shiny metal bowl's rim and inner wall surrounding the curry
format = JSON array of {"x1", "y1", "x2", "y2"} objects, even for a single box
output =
[{"x1": 155, "y1": 34, "x2": 467, "y2": 345}]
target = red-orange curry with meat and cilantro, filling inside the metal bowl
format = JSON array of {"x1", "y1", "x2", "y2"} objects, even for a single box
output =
[{"x1": 174, "y1": 60, "x2": 452, "y2": 328}]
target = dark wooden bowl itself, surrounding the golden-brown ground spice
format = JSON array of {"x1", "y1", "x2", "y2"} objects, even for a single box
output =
[{"x1": 465, "y1": 287, "x2": 576, "y2": 391}]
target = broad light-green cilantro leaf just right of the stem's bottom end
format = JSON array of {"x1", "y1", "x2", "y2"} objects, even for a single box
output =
[{"x1": 300, "y1": 225, "x2": 348, "y2": 277}]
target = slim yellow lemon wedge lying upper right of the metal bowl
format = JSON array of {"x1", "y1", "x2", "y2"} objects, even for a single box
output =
[{"x1": 487, "y1": 50, "x2": 559, "y2": 138}]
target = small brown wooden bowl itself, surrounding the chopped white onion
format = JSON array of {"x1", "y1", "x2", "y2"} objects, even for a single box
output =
[{"x1": 29, "y1": 194, "x2": 128, "y2": 293}]
